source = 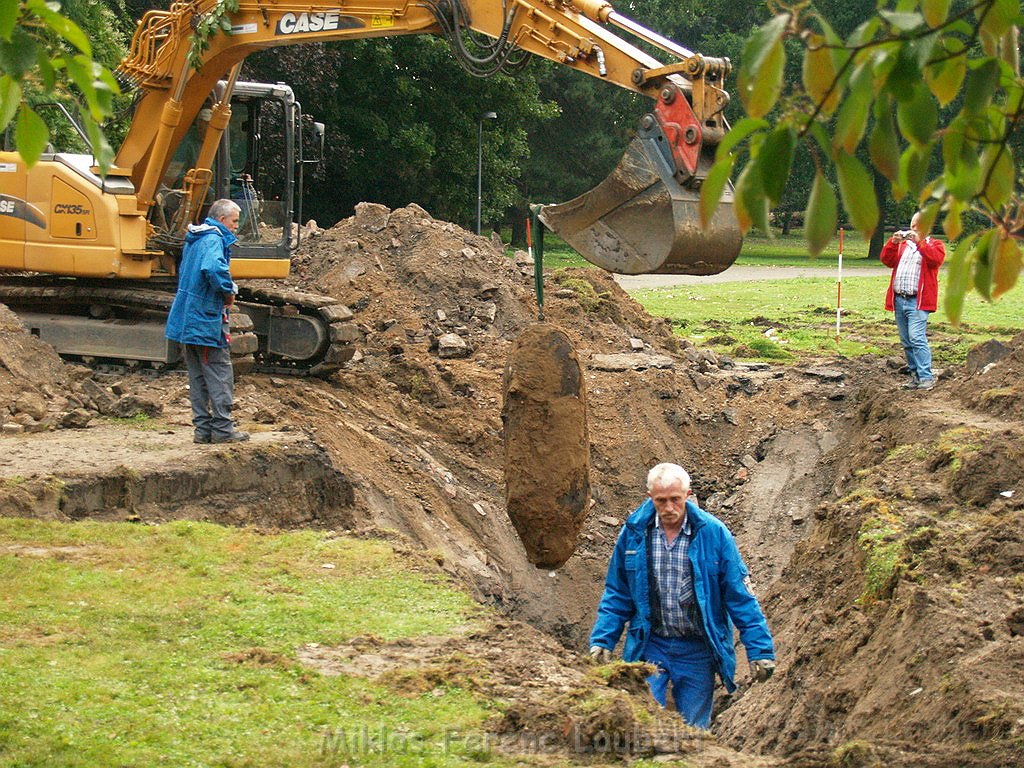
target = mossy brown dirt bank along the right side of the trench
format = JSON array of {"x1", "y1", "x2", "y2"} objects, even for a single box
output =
[{"x1": 718, "y1": 370, "x2": 1024, "y2": 768}]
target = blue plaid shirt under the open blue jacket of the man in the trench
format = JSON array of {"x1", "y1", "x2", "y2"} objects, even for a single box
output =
[{"x1": 649, "y1": 515, "x2": 703, "y2": 637}]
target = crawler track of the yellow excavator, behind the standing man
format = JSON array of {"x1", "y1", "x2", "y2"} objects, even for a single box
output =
[{"x1": 0, "y1": 276, "x2": 362, "y2": 377}]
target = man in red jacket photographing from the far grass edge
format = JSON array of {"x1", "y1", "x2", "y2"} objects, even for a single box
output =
[{"x1": 882, "y1": 212, "x2": 946, "y2": 389}]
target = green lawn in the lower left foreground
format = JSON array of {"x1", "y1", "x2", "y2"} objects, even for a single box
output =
[{"x1": 0, "y1": 518, "x2": 512, "y2": 768}]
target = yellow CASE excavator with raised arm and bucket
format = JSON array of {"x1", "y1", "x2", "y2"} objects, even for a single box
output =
[{"x1": 0, "y1": 0, "x2": 741, "y2": 375}]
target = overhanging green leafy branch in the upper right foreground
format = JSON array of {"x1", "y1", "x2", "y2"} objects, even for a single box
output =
[{"x1": 701, "y1": 0, "x2": 1024, "y2": 322}]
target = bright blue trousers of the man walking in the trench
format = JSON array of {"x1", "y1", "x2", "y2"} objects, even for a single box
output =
[{"x1": 644, "y1": 635, "x2": 716, "y2": 729}]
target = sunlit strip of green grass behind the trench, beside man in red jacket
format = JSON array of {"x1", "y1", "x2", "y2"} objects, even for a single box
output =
[{"x1": 633, "y1": 276, "x2": 1024, "y2": 365}]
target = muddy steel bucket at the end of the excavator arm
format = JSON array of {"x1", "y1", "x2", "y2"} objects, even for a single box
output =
[{"x1": 540, "y1": 121, "x2": 742, "y2": 274}]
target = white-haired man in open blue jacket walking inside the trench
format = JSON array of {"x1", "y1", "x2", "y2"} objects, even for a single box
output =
[{"x1": 590, "y1": 464, "x2": 775, "y2": 728}]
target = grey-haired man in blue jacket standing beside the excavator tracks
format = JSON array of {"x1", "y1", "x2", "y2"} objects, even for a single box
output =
[{"x1": 165, "y1": 200, "x2": 249, "y2": 442}]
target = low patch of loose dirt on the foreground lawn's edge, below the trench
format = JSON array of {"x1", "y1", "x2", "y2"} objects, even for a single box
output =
[{"x1": 292, "y1": 622, "x2": 777, "y2": 768}]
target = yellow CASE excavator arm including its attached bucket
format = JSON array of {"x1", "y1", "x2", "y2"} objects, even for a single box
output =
[{"x1": 115, "y1": 0, "x2": 741, "y2": 274}]
